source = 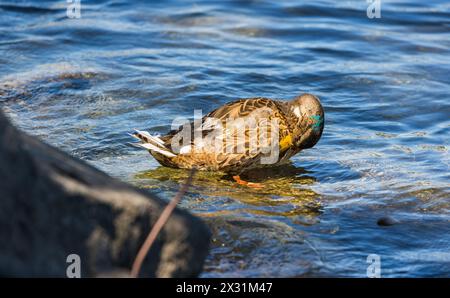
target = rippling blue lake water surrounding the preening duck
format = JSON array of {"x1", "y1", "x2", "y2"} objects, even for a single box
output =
[{"x1": 0, "y1": 0, "x2": 450, "y2": 277}]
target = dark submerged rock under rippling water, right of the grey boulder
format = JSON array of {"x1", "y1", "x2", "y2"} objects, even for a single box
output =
[{"x1": 203, "y1": 216, "x2": 323, "y2": 277}]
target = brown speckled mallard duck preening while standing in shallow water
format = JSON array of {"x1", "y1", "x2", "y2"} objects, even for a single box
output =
[{"x1": 131, "y1": 93, "x2": 325, "y2": 187}]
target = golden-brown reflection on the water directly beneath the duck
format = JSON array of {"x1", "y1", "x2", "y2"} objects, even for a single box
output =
[{"x1": 134, "y1": 164, "x2": 320, "y2": 217}]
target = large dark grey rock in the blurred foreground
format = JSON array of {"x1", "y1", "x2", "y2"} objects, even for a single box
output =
[{"x1": 0, "y1": 111, "x2": 210, "y2": 277}]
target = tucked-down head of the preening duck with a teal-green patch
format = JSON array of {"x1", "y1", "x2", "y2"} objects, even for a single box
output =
[{"x1": 289, "y1": 93, "x2": 325, "y2": 149}]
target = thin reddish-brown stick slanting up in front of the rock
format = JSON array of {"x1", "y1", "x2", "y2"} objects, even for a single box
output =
[{"x1": 131, "y1": 169, "x2": 195, "y2": 277}]
